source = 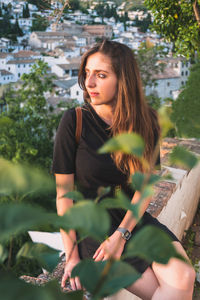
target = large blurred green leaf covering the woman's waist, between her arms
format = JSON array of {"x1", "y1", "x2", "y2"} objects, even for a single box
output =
[{"x1": 56, "y1": 201, "x2": 110, "y2": 241}]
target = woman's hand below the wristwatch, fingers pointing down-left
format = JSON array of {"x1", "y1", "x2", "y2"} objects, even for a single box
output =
[{"x1": 93, "y1": 231, "x2": 126, "y2": 261}]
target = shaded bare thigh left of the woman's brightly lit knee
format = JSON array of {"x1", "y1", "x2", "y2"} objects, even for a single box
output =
[{"x1": 126, "y1": 267, "x2": 159, "y2": 300}]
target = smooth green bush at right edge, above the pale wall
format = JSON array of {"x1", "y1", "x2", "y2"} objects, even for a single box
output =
[{"x1": 172, "y1": 62, "x2": 200, "y2": 138}]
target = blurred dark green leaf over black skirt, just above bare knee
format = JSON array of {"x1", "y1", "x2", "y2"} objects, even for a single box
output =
[{"x1": 123, "y1": 225, "x2": 184, "y2": 264}]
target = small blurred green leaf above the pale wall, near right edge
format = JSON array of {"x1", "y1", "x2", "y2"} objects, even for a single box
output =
[{"x1": 169, "y1": 146, "x2": 198, "y2": 170}]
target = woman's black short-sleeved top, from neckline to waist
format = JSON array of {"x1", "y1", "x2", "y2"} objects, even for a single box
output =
[{"x1": 52, "y1": 104, "x2": 159, "y2": 224}]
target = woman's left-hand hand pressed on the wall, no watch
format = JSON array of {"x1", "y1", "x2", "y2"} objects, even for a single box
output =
[{"x1": 61, "y1": 258, "x2": 82, "y2": 290}]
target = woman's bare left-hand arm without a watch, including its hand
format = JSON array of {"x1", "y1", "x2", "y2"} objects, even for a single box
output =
[{"x1": 55, "y1": 174, "x2": 81, "y2": 290}]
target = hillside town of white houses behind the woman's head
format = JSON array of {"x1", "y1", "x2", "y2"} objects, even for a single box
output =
[{"x1": 0, "y1": 0, "x2": 190, "y2": 108}]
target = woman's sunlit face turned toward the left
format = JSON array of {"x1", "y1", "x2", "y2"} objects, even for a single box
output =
[{"x1": 85, "y1": 52, "x2": 117, "y2": 105}]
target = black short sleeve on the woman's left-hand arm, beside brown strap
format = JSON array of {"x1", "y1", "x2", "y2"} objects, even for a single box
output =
[{"x1": 52, "y1": 108, "x2": 76, "y2": 174}]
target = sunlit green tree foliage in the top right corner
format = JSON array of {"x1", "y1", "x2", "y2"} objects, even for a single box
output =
[{"x1": 144, "y1": 0, "x2": 200, "y2": 57}]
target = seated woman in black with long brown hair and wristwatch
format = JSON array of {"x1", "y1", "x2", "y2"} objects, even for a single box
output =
[{"x1": 53, "y1": 40, "x2": 195, "y2": 300}]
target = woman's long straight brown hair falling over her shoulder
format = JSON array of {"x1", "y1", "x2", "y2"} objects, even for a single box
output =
[{"x1": 78, "y1": 40, "x2": 160, "y2": 175}]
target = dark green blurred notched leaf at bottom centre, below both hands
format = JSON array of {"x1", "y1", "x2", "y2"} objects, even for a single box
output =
[{"x1": 72, "y1": 259, "x2": 141, "y2": 299}]
